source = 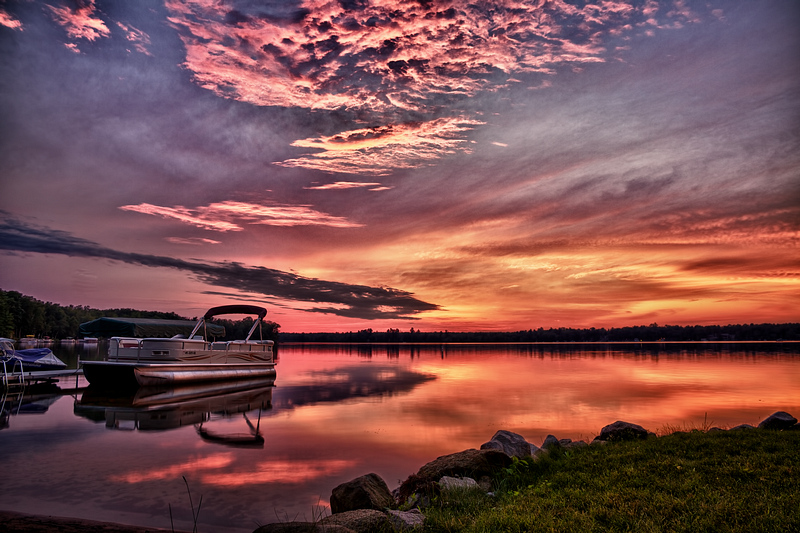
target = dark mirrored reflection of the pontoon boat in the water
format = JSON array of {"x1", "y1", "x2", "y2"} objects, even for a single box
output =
[{"x1": 74, "y1": 379, "x2": 275, "y2": 446}]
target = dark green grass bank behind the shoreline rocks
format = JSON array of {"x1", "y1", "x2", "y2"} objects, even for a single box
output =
[{"x1": 424, "y1": 430, "x2": 800, "y2": 533}]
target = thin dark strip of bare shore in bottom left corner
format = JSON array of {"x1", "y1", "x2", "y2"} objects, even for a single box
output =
[{"x1": 0, "y1": 511, "x2": 192, "y2": 533}]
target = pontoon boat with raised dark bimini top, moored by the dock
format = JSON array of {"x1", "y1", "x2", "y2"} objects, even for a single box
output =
[{"x1": 81, "y1": 305, "x2": 275, "y2": 389}]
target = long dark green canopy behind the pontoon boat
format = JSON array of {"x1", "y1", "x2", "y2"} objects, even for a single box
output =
[{"x1": 79, "y1": 317, "x2": 225, "y2": 338}]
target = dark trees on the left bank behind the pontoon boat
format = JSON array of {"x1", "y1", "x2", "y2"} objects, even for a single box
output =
[{"x1": 0, "y1": 289, "x2": 280, "y2": 340}]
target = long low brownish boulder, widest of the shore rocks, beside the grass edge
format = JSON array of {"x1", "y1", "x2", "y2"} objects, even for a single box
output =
[{"x1": 397, "y1": 449, "x2": 511, "y2": 502}]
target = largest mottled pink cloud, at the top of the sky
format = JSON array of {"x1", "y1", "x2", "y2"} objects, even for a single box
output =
[{"x1": 167, "y1": 0, "x2": 656, "y2": 111}]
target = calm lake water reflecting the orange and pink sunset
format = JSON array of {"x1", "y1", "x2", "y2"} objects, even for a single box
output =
[{"x1": 0, "y1": 343, "x2": 800, "y2": 532}]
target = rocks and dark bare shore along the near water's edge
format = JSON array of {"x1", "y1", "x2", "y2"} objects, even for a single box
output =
[{"x1": 0, "y1": 411, "x2": 800, "y2": 533}]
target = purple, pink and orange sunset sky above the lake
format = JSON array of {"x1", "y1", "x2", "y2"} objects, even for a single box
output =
[{"x1": 0, "y1": 0, "x2": 800, "y2": 332}]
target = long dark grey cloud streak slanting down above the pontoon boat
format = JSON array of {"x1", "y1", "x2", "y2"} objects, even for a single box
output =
[{"x1": 0, "y1": 216, "x2": 438, "y2": 320}]
